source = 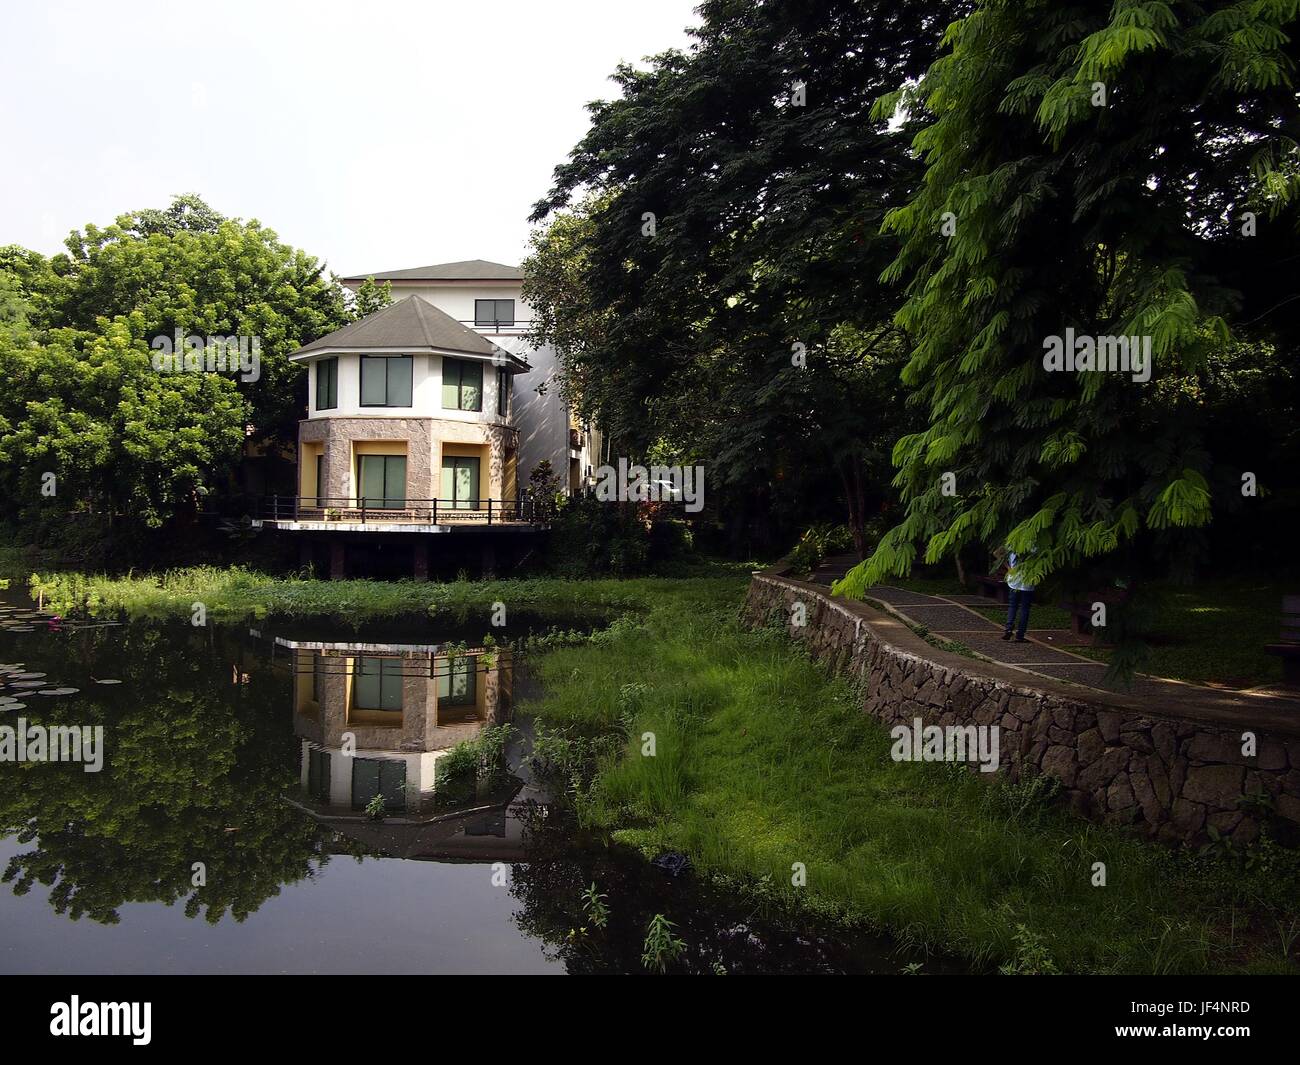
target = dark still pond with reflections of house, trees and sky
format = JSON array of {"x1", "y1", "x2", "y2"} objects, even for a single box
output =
[{"x1": 0, "y1": 593, "x2": 956, "y2": 974}]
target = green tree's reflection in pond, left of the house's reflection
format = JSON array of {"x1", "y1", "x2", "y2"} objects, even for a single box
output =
[{"x1": 0, "y1": 625, "x2": 325, "y2": 923}]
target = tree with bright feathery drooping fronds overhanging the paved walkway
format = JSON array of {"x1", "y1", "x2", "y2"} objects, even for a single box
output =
[{"x1": 841, "y1": 0, "x2": 1300, "y2": 594}]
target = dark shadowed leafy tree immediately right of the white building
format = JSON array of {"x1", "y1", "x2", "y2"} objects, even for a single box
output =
[{"x1": 525, "y1": 0, "x2": 961, "y2": 559}]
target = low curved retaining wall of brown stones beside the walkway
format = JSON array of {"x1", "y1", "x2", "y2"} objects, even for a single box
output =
[{"x1": 744, "y1": 573, "x2": 1300, "y2": 843}]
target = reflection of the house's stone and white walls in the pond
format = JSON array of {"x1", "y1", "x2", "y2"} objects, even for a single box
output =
[{"x1": 267, "y1": 637, "x2": 512, "y2": 818}]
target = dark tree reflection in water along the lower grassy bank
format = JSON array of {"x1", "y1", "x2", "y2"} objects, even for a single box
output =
[{"x1": 511, "y1": 808, "x2": 909, "y2": 973}]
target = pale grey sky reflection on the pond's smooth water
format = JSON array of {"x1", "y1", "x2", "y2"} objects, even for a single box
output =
[{"x1": 0, "y1": 837, "x2": 563, "y2": 974}]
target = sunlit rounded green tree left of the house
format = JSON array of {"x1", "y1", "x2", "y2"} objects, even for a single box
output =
[{"x1": 0, "y1": 196, "x2": 348, "y2": 548}]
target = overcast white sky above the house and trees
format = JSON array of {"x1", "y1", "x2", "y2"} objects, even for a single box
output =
[{"x1": 0, "y1": 0, "x2": 697, "y2": 274}]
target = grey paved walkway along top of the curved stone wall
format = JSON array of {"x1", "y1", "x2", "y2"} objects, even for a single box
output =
[{"x1": 810, "y1": 555, "x2": 1300, "y2": 713}]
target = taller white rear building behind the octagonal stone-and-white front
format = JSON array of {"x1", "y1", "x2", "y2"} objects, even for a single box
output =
[{"x1": 332, "y1": 259, "x2": 602, "y2": 494}]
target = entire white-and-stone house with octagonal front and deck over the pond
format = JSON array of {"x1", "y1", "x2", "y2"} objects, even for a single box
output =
[{"x1": 263, "y1": 260, "x2": 599, "y2": 579}]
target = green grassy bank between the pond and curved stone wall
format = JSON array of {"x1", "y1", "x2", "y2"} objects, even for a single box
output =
[{"x1": 532, "y1": 581, "x2": 1297, "y2": 973}]
